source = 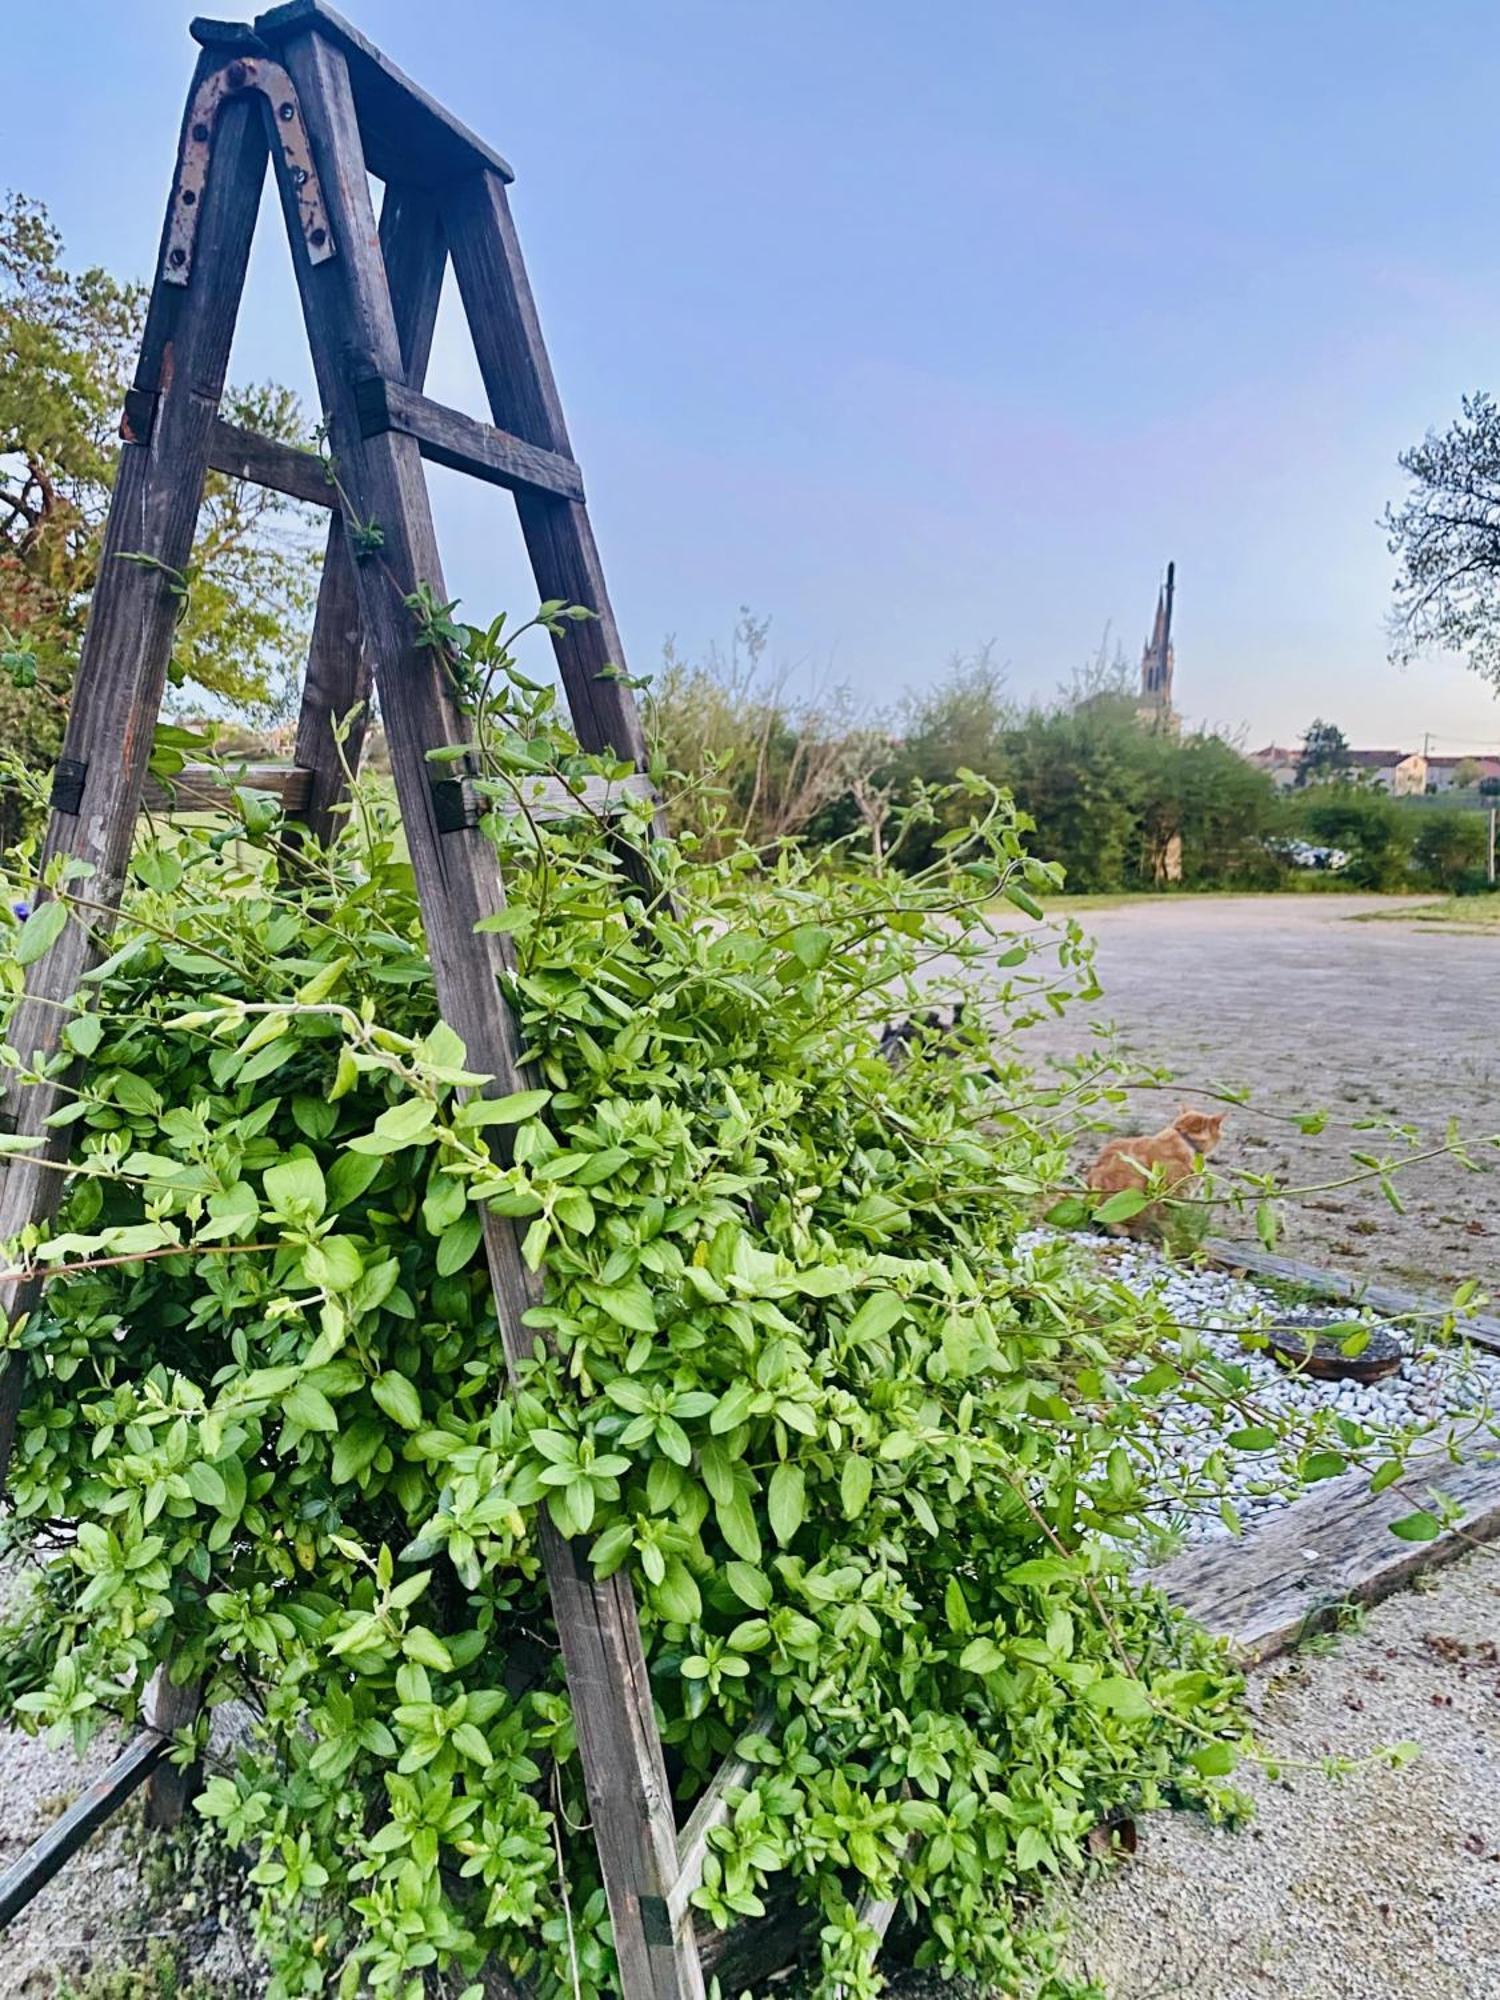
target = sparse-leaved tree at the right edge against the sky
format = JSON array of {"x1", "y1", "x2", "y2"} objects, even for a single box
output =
[{"x1": 1384, "y1": 394, "x2": 1500, "y2": 686}]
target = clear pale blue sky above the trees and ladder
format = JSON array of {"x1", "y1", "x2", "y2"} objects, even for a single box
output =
[{"x1": 0, "y1": 0, "x2": 1500, "y2": 750}]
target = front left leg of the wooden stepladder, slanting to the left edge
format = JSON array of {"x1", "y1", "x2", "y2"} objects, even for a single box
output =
[{"x1": 0, "y1": 52, "x2": 266, "y2": 1486}]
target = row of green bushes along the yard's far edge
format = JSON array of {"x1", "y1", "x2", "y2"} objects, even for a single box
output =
[{"x1": 644, "y1": 612, "x2": 1486, "y2": 894}]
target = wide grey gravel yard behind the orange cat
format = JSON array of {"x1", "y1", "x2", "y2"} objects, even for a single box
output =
[{"x1": 1026, "y1": 896, "x2": 1500, "y2": 1288}]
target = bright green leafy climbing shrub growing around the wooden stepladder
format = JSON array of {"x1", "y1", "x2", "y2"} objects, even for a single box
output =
[{"x1": 0, "y1": 606, "x2": 1256, "y2": 2000}]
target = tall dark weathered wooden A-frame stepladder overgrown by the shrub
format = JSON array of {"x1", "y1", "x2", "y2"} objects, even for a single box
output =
[{"x1": 0, "y1": 0, "x2": 722, "y2": 2000}]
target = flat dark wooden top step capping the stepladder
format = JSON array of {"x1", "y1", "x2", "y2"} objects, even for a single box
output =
[{"x1": 256, "y1": 0, "x2": 516, "y2": 188}]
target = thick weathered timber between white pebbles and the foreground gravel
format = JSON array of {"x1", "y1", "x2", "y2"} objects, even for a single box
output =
[{"x1": 1152, "y1": 1452, "x2": 1500, "y2": 1662}]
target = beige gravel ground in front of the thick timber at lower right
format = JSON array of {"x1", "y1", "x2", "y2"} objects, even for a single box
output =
[{"x1": 1068, "y1": 1550, "x2": 1500, "y2": 2000}]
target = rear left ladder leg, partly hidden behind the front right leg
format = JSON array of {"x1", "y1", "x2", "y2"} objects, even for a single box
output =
[{"x1": 294, "y1": 186, "x2": 448, "y2": 840}]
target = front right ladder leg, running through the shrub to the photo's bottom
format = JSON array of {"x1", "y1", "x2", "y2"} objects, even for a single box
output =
[{"x1": 268, "y1": 34, "x2": 704, "y2": 2000}]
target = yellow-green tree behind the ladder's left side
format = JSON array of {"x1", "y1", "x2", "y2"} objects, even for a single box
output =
[{"x1": 0, "y1": 194, "x2": 316, "y2": 832}]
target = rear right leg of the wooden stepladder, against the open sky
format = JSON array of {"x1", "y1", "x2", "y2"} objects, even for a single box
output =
[{"x1": 442, "y1": 172, "x2": 646, "y2": 768}]
